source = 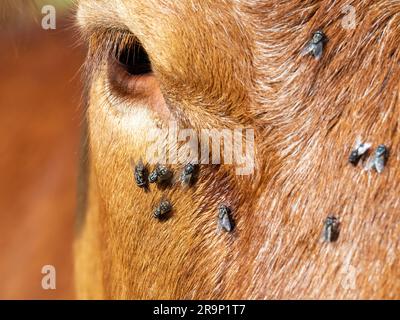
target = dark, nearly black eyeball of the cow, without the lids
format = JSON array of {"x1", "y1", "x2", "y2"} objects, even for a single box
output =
[{"x1": 115, "y1": 41, "x2": 152, "y2": 76}]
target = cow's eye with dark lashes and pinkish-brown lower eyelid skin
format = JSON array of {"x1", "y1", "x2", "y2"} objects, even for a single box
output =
[{"x1": 101, "y1": 31, "x2": 170, "y2": 120}]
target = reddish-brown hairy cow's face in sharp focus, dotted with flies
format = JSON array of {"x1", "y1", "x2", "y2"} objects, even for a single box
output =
[{"x1": 75, "y1": 0, "x2": 400, "y2": 299}]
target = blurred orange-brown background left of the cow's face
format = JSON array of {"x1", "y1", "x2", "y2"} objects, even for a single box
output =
[{"x1": 0, "y1": 0, "x2": 85, "y2": 299}]
